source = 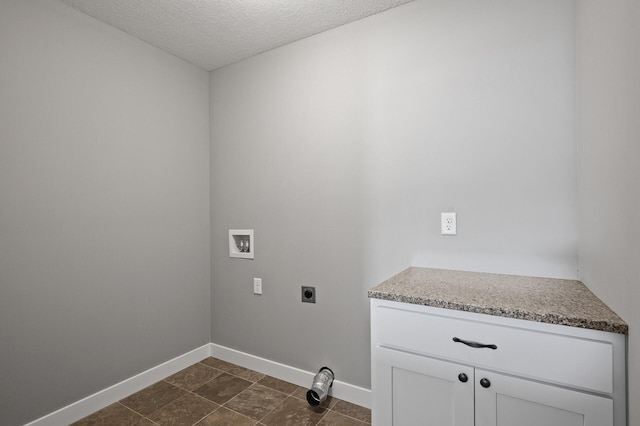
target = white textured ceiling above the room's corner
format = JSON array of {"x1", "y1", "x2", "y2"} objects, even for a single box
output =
[{"x1": 62, "y1": 0, "x2": 411, "y2": 71}]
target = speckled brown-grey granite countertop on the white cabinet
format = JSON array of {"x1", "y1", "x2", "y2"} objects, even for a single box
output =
[{"x1": 368, "y1": 266, "x2": 628, "y2": 334}]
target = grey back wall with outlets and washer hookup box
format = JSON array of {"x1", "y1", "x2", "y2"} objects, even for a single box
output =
[{"x1": 211, "y1": 0, "x2": 578, "y2": 387}]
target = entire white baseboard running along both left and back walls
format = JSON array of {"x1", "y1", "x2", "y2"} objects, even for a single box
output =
[{"x1": 25, "y1": 343, "x2": 371, "y2": 426}]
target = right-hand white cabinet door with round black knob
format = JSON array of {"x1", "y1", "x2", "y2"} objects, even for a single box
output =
[{"x1": 475, "y1": 369, "x2": 613, "y2": 426}]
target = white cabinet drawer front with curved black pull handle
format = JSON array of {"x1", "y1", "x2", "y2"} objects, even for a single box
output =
[{"x1": 372, "y1": 305, "x2": 613, "y2": 394}]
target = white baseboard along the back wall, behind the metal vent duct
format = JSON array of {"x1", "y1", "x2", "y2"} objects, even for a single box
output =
[{"x1": 211, "y1": 343, "x2": 371, "y2": 408}]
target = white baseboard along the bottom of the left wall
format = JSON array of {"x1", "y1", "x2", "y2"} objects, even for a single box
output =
[{"x1": 25, "y1": 344, "x2": 211, "y2": 426}]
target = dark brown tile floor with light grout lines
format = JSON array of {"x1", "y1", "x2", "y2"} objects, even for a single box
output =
[{"x1": 74, "y1": 358, "x2": 371, "y2": 426}]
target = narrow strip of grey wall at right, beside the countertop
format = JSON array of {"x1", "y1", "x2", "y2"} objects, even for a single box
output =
[{"x1": 577, "y1": 0, "x2": 640, "y2": 425}]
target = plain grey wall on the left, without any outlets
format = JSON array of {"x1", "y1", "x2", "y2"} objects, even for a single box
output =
[{"x1": 0, "y1": 0, "x2": 210, "y2": 425}]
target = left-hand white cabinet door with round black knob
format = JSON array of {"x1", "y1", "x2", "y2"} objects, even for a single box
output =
[{"x1": 372, "y1": 347, "x2": 474, "y2": 426}]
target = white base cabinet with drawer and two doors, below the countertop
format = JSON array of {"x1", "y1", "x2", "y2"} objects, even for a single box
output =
[{"x1": 371, "y1": 299, "x2": 626, "y2": 426}]
